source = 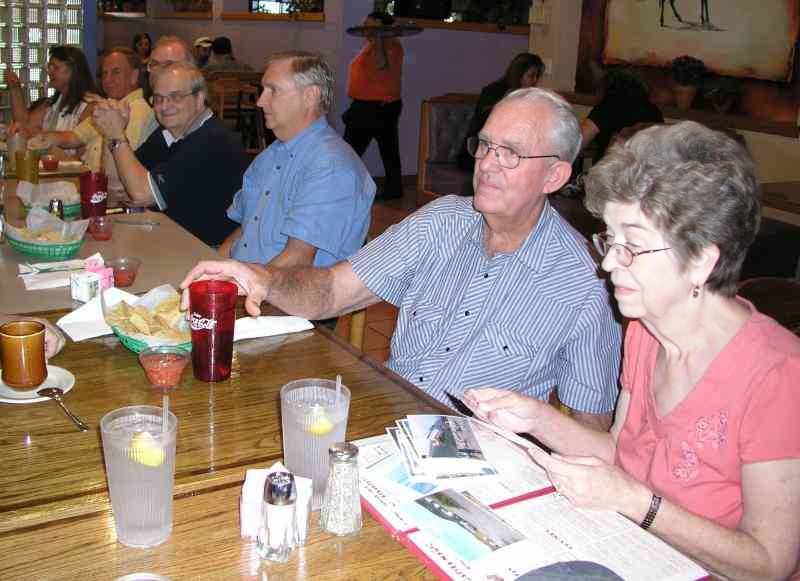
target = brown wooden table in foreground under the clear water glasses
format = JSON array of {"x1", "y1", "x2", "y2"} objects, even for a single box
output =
[{"x1": 0, "y1": 312, "x2": 445, "y2": 581}]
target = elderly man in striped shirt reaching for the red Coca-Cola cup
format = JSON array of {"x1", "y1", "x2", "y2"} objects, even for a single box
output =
[{"x1": 182, "y1": 88, "x2": 620, "y2": 429}]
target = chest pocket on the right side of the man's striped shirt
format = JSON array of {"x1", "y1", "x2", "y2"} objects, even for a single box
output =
[{"x1": 464, "y1": 321, "x2": 538, "y2": 390}]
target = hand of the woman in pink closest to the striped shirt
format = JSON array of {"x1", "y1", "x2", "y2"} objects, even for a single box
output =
[{"x1": 464, "y1": 387, "x2": 548, "y2": 433}]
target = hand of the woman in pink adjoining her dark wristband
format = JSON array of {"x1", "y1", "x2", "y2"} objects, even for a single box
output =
[{"x1": 529, "y1": 448, "x2": 652, "y2": 522}]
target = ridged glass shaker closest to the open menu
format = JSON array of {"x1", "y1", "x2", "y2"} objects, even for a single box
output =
[{"x1": 320, "y1": 442, "x2": 361, "y2": 536}]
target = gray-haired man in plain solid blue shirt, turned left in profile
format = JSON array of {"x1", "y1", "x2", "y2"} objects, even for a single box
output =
[{"x1": 220, "y1": 51, "x2": 375, "y2": 266}]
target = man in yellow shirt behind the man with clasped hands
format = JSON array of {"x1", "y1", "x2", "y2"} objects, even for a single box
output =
[{"x1": 44, "y1": 47, "x2": 158, "y2": 199}]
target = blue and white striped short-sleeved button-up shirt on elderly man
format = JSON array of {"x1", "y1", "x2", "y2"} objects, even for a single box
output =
[{"x1": 349, "y1": 196, "x2": 620, "y2": 413}]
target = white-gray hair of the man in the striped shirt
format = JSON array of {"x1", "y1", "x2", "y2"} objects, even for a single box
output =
[{"x1": 500, "y1": 87, "x2": 581, "y2": 163}]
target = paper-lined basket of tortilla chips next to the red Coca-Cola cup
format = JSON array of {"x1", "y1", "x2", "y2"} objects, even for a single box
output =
[{"x1": 102, "y1": 285, "x2": 192, "y2": 353}]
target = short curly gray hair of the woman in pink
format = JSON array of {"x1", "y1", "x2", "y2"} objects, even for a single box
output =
[{"x1": 584, "y1": 121, "x2": 761, "y2": 296}]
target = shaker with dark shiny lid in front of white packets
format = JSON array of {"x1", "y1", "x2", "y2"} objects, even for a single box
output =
[{"x1": 257, "y1": 472, "x2": 297, "y2": 563}]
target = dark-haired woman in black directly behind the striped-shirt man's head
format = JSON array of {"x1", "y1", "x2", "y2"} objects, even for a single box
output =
[{"x1": 458, "y1": 52, "x2": 544, "y2": 171}]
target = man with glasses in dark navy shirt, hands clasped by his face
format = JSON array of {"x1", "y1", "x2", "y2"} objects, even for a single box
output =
[{"x1": 93, "y1": 61, "x2": 248, "y2": 246}]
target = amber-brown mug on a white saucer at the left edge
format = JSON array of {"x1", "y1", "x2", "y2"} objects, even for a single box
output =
[{"x1": 0, "y1": 321, "x2": 47, "y2": 389}]
